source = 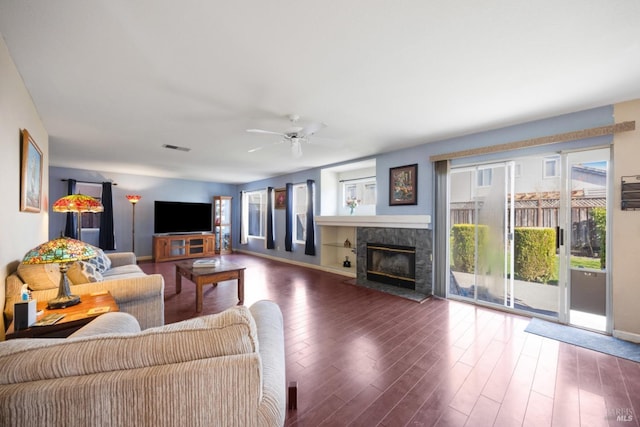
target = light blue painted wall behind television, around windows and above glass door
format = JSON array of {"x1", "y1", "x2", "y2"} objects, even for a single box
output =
[{"x1": 49, "y1": 106, "x2": 613, "y2": 265}]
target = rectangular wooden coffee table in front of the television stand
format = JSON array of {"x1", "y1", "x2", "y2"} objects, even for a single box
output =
[{"x1": 176, "y1": 259, "x2": 245, "y2": 313}]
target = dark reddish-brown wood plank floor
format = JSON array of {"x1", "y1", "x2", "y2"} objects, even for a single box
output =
[{"x1": 141, "y1": 254, "x2": 640, "y2": 427}]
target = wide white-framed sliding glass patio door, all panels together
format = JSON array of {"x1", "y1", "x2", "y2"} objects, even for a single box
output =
[{"x1": 448, "y1": 148, "x2": 610, "y2": 331}]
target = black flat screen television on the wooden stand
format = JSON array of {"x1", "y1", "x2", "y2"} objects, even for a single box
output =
[{"x1": 153, "y1": 200, "x2": 213, "y2": 234}]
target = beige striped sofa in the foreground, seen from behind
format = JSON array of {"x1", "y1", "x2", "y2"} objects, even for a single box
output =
[{"x1": 0, "y1": 300, "x2": 286, "y2": 427}]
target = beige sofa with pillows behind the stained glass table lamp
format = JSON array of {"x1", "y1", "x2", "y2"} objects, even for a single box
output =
[{"x1": 0, "y1": 248, "x2": 164, "y2": 336}]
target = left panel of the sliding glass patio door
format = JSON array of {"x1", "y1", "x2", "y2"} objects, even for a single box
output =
[{"x1": 449, "y1": 162, "x2": 514, "y2": 308}]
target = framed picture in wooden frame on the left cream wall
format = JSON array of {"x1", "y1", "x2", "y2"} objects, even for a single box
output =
[{"x1": 20, "y1": 129, "x2": 42, "y2": 212}]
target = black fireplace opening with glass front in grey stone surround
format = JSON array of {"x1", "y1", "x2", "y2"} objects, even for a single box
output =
[{"x1": 367, "y1": 243, "x2": 416, "y2": 290}]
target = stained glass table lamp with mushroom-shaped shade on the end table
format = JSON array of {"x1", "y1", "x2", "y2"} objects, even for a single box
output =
[{"x1": 22, "y1": 237, "x2": 96, "y2": 309}]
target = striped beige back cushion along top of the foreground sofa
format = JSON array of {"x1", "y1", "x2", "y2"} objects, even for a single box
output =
[{"x1": 0, "y1": 306, "x2": 258, "y2": 384}]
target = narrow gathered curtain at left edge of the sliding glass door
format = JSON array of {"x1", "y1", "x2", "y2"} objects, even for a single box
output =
[{"x1": 433, "y1": 160, "x2": 449, "y2": 297}]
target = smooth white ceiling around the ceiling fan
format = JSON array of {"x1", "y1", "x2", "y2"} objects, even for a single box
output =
[{"x1": 0, "y1": 0, "x2": 640, "y2": 183}]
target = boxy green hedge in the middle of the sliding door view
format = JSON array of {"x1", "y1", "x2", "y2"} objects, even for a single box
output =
[{"x1": 513, "y1": 227, "x2": 556, "y2": 283}]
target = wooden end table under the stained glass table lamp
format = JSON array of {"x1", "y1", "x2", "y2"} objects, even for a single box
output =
[{"x1": 6, "y1": 291, "x2": 119, "y2": 339}]
